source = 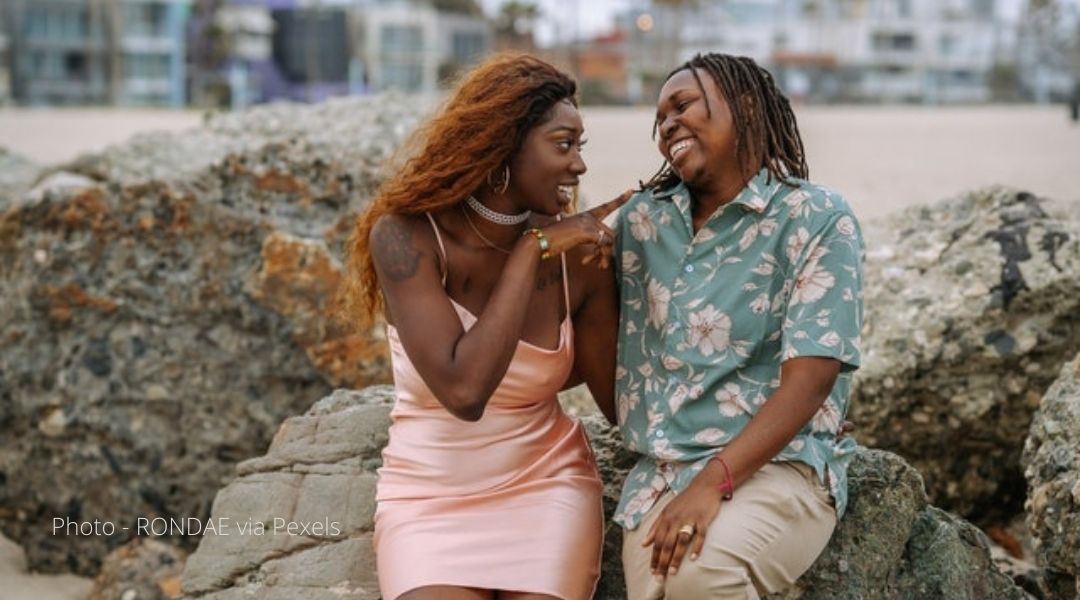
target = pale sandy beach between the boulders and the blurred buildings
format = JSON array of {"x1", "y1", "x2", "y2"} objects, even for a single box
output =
[{"x1": 0, "y1": 106, "x2": 1080, "y2": 220}]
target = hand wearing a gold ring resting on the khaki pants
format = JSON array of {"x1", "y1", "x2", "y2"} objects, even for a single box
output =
[{"x1": 642, "y1": 475, "x2": 723, "y2": 577}]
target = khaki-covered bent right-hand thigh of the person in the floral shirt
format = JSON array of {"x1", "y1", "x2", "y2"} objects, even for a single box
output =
[{"x1": 676, "y1": 463, "x2": 836, "y2": 594}]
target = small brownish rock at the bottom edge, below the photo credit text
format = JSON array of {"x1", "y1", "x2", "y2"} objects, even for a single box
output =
[{"x1": 90, "y1": 537, "x2": 187, "y2": 600}]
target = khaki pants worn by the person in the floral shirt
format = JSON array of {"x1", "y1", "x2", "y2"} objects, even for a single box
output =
[{"x1": 622, "y1": 463, "x2": 836, "y2": 600}]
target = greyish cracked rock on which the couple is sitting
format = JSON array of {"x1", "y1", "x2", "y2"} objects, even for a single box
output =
[{"x1": 183, "y1": 387, "x2": 1024, "y2": 600}]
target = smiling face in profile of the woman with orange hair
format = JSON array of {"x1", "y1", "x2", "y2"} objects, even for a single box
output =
[{"x1": 507, "y1": 100, "x2": 585, "y2": 215}]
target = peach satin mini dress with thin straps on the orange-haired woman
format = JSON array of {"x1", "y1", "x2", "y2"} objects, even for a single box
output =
[{"x1": 375, "y1": 215, "x2": 604, "y2": 600}]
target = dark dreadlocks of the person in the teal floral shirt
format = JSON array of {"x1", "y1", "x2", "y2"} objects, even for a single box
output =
[{"x1": 642, "y1": 53, "x2": 810, "y2": 190}]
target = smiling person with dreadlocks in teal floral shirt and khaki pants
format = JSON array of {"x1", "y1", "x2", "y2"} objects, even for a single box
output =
[{"x1": 615, "y1": 54, "x2": 863, "y2": 600}]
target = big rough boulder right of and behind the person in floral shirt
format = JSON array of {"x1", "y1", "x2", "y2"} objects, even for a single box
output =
[{"x1": 849, "y1": 188, "x2": 1080, "y2": 521}]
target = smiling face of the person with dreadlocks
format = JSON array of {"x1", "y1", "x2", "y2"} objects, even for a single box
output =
[{"x1": 657, "y1": 69, "x2": 741, "y2": 193}]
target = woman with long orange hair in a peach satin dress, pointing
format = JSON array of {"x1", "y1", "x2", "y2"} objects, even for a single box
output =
[{"x1": 350, "y1": 55, "x2": 620, "y2": 600}]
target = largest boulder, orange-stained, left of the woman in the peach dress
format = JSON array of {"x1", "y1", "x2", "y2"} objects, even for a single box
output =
[{"x1": 0, "y1": 96, "x2": 422, "y2": 574}]
